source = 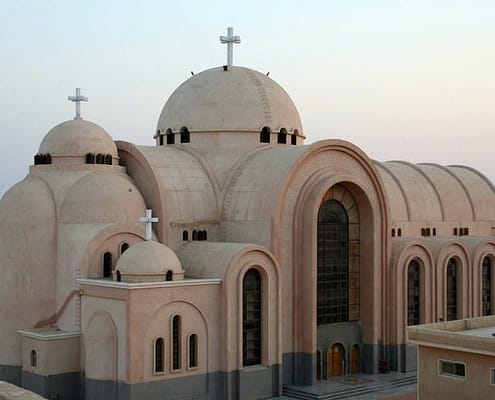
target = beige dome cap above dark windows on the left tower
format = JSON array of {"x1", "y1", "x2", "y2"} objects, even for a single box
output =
[{"x1": 39, "y1": 118, "x2": 118, "y2": 157}]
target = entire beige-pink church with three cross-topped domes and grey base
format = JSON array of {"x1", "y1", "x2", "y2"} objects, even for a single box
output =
[{"x1": 0, "y1": 29, "x2": 495, "y2": 400}]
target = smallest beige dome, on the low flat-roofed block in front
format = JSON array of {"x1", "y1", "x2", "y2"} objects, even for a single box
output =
[{"x1": 115, "y1": 240, "x2": 184, "y2": 282}]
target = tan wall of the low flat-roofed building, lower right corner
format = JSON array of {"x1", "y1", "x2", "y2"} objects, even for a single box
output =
[{"x1": 418, "y1": 346, "x2": 495, "y2": 400}]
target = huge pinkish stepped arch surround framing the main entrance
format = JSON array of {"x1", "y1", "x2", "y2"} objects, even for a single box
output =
[{"x1": 278, "y1": 140, "x2": 389, "y2": 384}]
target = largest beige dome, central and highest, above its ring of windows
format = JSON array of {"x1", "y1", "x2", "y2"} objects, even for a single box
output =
[{"x1": 157, "y1": 67, "x2": 303, "y2": 135}]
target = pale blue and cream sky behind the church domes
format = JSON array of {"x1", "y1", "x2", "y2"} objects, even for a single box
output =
[{"x1": 0, "y1": 0, "x2": 495, "y2": 196}]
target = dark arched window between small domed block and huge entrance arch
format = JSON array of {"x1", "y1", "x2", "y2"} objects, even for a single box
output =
[{"x1": 242, "y1": 268, "x2": 262, "y2": 366}]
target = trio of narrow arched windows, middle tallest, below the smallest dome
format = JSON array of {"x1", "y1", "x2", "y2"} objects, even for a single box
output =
[{"x1": 153, "y1": 315, "x2": 198, "y2": 374}]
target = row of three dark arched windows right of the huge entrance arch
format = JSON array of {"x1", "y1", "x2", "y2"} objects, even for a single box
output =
[{"x1": 407, "y1": 256, "x2": 493, "y2": 325}]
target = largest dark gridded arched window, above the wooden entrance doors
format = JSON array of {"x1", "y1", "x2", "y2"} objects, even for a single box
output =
[{"x1": 317, "y1": 200, "x2": 349, "y2": 325}]
